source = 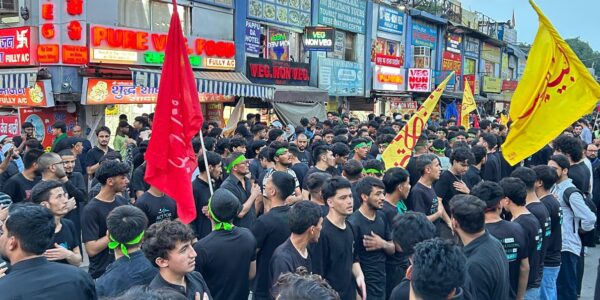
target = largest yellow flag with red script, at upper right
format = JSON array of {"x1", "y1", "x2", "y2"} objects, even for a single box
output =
[{"x1": 502, "y1": 0, "x2": 600, "y2": 166}]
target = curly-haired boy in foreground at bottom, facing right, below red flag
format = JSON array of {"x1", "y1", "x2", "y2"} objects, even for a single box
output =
[{"x1": 142, "y1": 221, "x2": 212, "y2": 300}]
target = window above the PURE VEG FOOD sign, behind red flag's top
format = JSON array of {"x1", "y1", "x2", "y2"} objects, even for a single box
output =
[{"x1": 119, "y1": 0, "x2": 190, "y2": 34}]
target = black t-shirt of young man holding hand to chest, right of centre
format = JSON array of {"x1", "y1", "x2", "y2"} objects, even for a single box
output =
[{"x1": 348, "y1": 210, "x2": 391, "y2": 298}]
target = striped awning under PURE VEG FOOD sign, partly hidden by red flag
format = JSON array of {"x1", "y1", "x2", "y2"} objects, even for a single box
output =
[{"x1": 130, "y1": 68, "x2": 275, "y2": 100}]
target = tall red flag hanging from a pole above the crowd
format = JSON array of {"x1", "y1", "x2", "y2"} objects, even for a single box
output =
[{"x1": 144, "y1": 0, "x2": 203, "y2": 223}]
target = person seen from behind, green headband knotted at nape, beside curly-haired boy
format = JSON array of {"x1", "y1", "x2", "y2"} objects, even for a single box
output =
[{"x1": 194, "y1": 189, "x2": 256, "y2": 300}]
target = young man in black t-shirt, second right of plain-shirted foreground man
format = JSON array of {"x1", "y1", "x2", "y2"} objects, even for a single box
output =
[{"x1": 500, "y1": 177, "x2": 542, "y2": 299}]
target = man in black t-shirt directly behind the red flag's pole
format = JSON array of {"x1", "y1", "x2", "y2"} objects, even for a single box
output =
[{"x1": 190, "y1": 151, "x2": 223, "y2": 240}]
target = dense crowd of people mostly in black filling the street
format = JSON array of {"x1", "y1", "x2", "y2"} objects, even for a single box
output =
[{"x1": 0, "y1": 113, "x2": 600, "y2": 300}]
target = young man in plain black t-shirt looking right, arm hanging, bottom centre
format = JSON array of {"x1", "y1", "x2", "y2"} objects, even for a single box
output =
[{"x1": 311, "y1": 176, "x2": 367, "y2": 300}]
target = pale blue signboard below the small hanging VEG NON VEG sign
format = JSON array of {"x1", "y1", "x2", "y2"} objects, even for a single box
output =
[{"x1": 319, "y1": 57, "x2": 365, "y2": 96}]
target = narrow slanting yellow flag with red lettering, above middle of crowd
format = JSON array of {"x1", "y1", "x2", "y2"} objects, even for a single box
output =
[{"x1": 381, "y1": 72, "x2": 454, "y2": 169}]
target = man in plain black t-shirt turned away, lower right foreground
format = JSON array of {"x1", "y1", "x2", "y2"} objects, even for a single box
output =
[{"x1": 450, "y1": 195, "x2": 510, "y2": 299}]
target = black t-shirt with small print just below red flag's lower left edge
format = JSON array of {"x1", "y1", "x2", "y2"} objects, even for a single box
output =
[{"x1": 135, "y1": 192, "x2": 177, "y2": 226}]
